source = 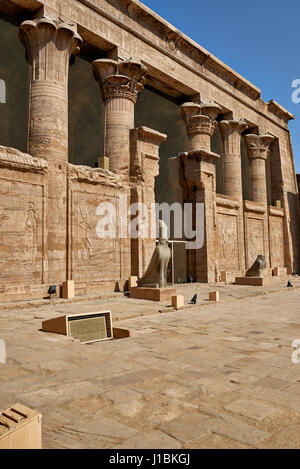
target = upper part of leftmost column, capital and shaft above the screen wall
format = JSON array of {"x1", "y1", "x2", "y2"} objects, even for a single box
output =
[{"x1": 20, "y1": 18, "x2": 82, "y2": 162}]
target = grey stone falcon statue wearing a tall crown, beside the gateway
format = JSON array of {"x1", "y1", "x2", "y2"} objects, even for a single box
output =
[{"x1": 138, "y1": 221, "x2": 171, "y2": 288}]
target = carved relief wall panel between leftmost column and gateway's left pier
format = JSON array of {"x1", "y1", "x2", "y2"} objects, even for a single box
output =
[{"x1": 71, "y1": 191, "x2": 120, "y2": 282}]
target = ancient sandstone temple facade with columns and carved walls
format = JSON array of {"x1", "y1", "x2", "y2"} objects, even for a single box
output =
[{"x1": 0, "y1": 0, "x2": 300, "y2": 300}]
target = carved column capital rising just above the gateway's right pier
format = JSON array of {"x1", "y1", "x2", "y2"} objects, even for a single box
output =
[{"x1": 181, "y1": 102, "x2": 221, "y2": 151}]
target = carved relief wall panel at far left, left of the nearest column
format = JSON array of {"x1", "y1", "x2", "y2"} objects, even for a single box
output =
[{"x1": 0, "y1": 179, "x2": 43, "y2": 285}]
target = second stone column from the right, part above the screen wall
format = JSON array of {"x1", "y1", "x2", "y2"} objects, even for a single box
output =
[{"x1": 220, "y1": 120, "x2": 247, "y2": 203}]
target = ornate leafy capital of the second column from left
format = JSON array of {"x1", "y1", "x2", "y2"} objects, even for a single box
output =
[{"x1": 93, "y1": 59, "x2": 147, "y2": 104}]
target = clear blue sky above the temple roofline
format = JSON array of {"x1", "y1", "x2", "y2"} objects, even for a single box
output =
[{"x1": 143, "y1": 0, "x2": 300, "y2": 173}]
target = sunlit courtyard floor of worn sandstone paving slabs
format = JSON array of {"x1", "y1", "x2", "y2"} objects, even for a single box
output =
[{"x1": 0, "y1": 278, "x2": 300, "y2": 449}]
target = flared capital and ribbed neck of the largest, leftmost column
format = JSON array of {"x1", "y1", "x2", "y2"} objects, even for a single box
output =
[{"x1": 19, "y1": 17, "x2": 82, "y2": 84}]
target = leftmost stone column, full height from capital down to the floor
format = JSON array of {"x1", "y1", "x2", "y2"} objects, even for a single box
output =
[{"x1": 20, "y1": 18, "x2": 82, "y2": 284}]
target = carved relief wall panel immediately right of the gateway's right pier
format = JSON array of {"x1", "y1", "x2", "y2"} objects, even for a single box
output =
[{"x1": 218, "y1": 213, "x2": 239, "y2": 271}]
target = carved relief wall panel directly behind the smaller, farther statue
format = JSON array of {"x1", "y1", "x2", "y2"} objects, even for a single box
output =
[{"x1": 246, "y1": 218, "x2": 265, "y2": 268}]
